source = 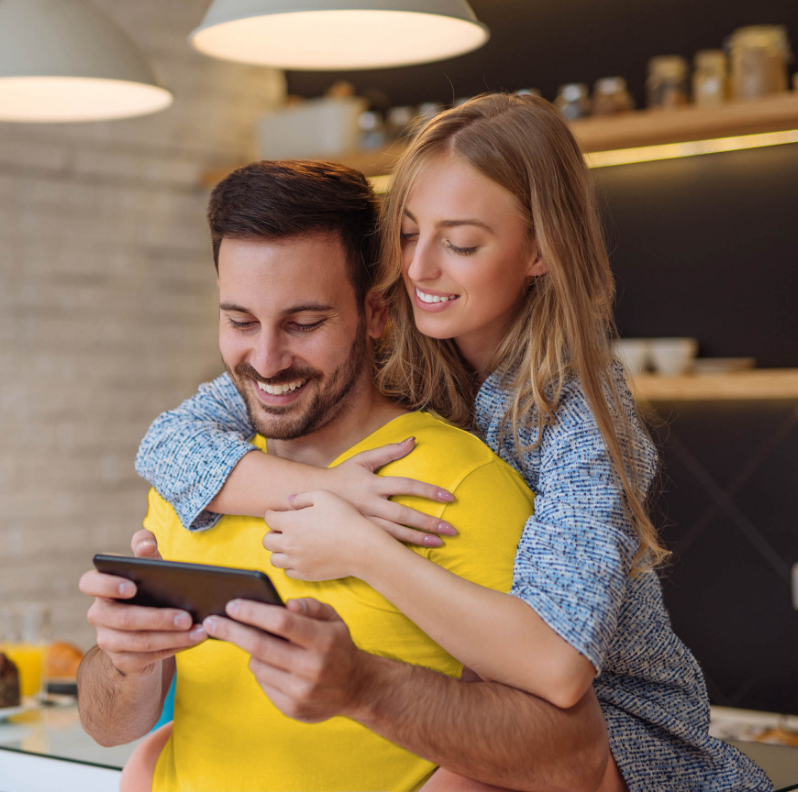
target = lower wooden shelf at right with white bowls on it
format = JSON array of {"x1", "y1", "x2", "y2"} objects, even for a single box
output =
[{"x1": 630, "y1": 369, "x2": 798, "y2": 401}]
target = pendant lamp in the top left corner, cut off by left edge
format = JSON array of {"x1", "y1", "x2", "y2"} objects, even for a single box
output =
[{"x1": 0, "y1": 0, "x2": 172, "y2": 122}]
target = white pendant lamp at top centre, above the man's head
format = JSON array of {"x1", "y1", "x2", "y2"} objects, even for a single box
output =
[{"x1": 189, "y1": 0, "x2": 490, "y2": 71}]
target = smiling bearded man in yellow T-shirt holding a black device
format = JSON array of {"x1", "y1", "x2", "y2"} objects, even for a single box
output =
[{"x1": 79, "y1": 163, "x2": 611, "y2": 792}]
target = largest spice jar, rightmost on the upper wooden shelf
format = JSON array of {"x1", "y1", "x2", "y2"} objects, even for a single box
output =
[{"x1": 727, "y1": 25, "x2": 792, "y2": 99}]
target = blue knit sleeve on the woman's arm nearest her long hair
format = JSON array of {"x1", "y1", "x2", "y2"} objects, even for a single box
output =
[{"x1": 512, "y1": 380, "x2": 656, "y2": 673}]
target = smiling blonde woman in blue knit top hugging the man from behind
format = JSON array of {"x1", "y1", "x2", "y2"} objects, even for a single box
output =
[{"x1": 138, "y1": 95, "x2": 771, "y2": 791}]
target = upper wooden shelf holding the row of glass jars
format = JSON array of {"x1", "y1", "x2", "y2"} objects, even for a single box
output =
[{"x1": 198, "y1": 93, "x2": 798, "y2": 187}]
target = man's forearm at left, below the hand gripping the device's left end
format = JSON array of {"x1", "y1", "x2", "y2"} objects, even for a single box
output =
[{"x1": 78, "y1": 646, "x2": 174, "y2": 746}]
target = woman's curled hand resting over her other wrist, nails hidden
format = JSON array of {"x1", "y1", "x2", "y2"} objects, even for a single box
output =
[{"x1": 263, "y1": 490, "x2": 404, "y2": 581}]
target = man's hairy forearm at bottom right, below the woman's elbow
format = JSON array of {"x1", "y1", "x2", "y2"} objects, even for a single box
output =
[{"x1": 347, "y1": 655, "x2": 609, "y2": 792}]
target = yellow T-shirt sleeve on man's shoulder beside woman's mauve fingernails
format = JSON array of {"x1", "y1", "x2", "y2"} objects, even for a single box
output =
[{"x1": 424, "y1": 459, "x2": 534, "y2": 593}]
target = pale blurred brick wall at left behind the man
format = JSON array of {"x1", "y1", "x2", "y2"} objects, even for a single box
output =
[{"x1": 0, "y1": 0, "x2": 285, "y2": 649}]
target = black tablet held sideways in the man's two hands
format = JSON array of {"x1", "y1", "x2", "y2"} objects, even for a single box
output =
[{"x1": 94, "y1": 553, "x2": 283, "y2": 624}]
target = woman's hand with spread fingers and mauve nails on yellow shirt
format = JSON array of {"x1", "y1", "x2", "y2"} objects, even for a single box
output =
[{"x1": 325, "y1": 437, "x2": 457, "y2": 547}]
